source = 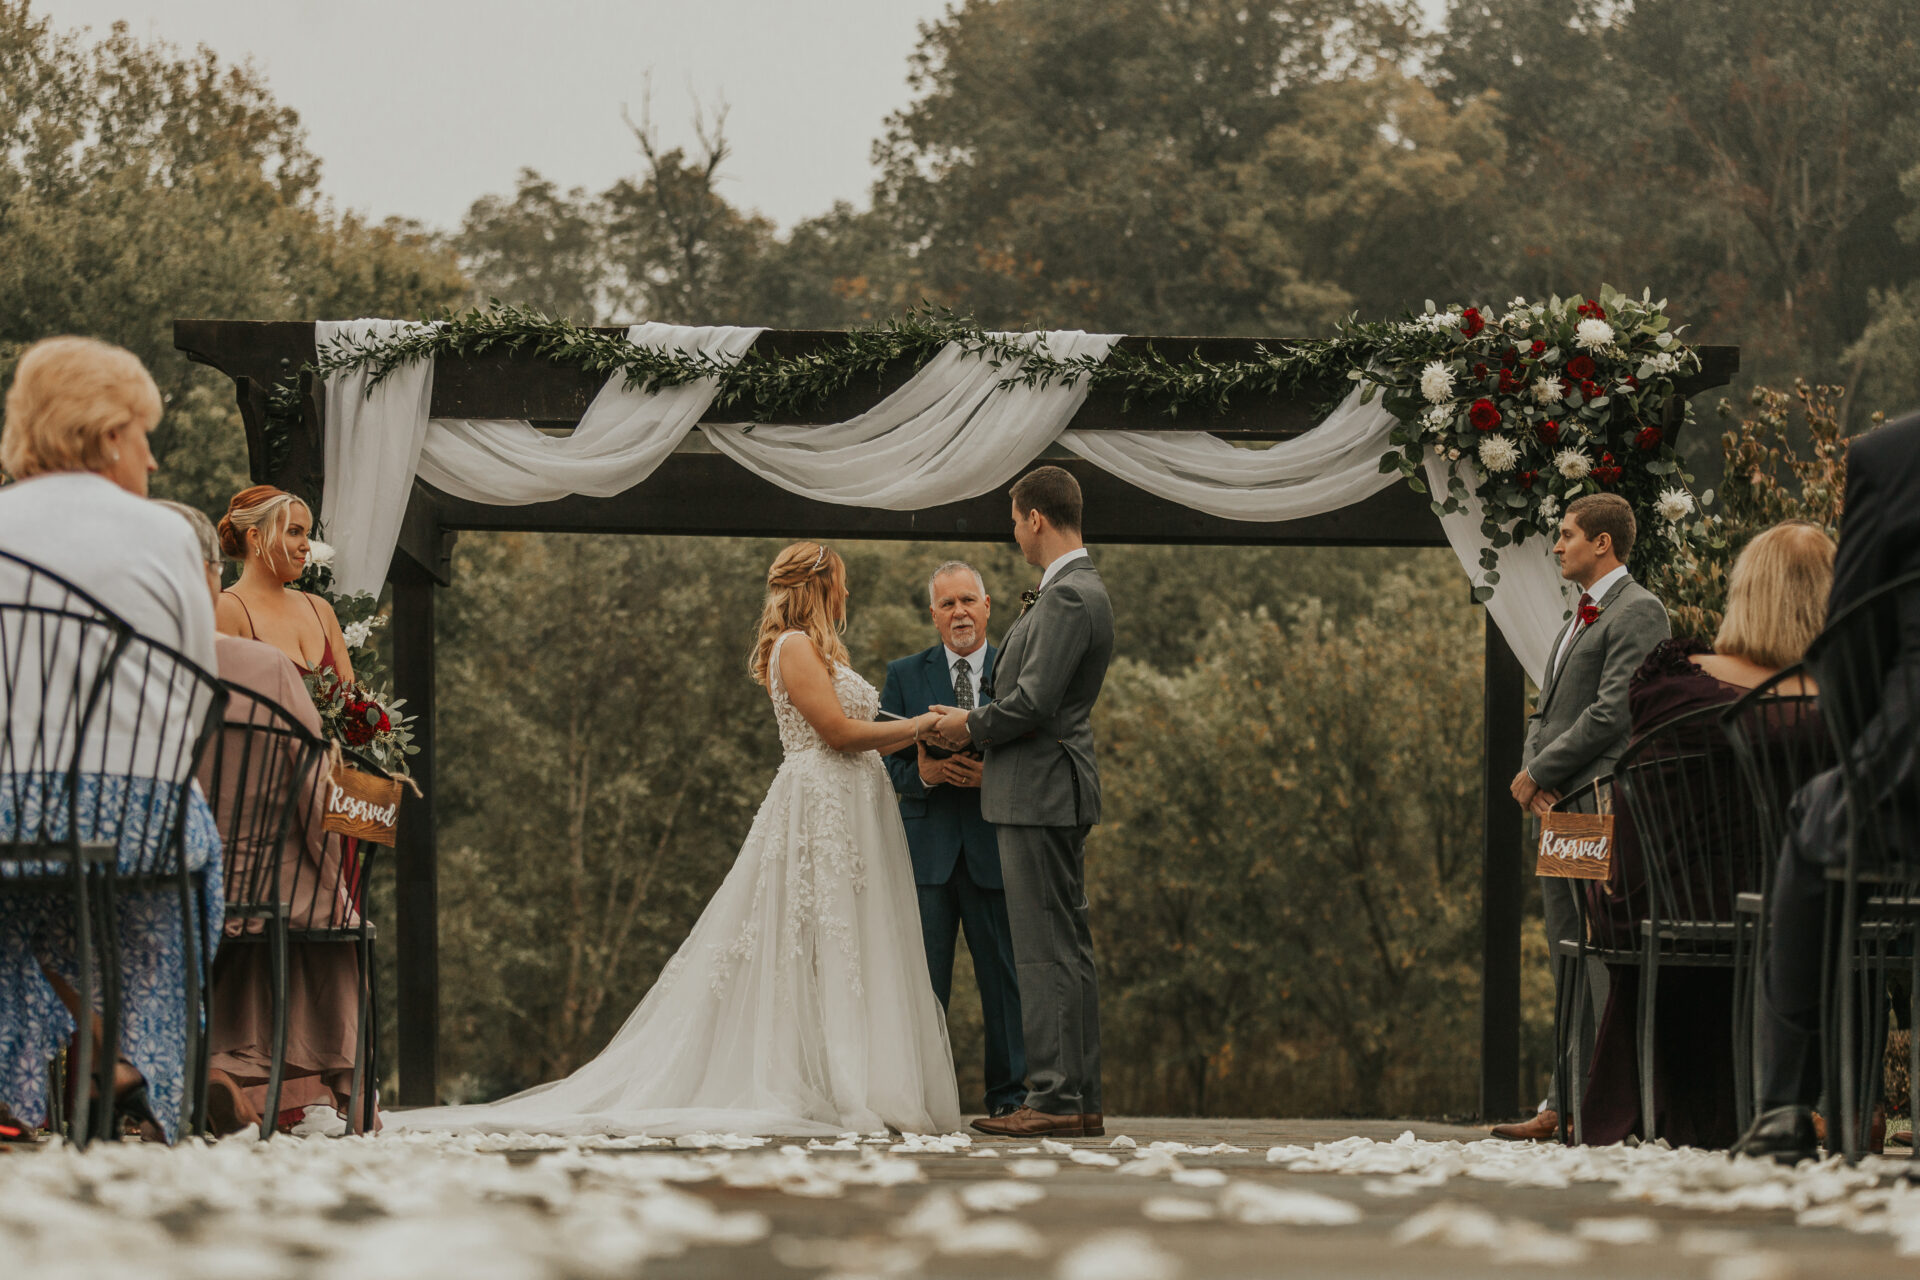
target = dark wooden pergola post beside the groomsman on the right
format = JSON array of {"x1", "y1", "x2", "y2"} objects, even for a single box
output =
[{"x1": 1480, "y1": 614, "x2": 1532, "y2": 1121}]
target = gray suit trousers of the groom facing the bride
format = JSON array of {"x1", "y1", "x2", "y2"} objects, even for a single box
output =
[{"x1": 998, "y1": 827, "x2": 1100, "y2": 1115}]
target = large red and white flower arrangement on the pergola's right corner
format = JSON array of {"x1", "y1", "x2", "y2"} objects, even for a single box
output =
[{"x1": 1350, "y1": 286, "x2": 1713, "y2": 601}]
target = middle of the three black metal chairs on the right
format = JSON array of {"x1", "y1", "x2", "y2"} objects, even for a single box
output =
[{"x1": 1720, "y1": 664, "x2": 1834, "y2": 1130}]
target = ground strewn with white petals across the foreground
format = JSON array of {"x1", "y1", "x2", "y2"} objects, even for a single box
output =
[{"x1": 0, "y1": 1119, "x2": 1920, "y2": 1280}]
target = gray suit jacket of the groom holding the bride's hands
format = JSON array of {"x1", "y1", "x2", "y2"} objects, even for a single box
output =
[{"x1": 968, "y1": 558, "x2": 1114, "y2": 827}]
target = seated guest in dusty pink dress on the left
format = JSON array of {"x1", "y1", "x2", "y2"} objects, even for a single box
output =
[{"x1": 169, "y1": 503, "x2": 376, "y2": 1134}]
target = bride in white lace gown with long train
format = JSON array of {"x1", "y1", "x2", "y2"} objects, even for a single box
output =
[{"x1": 388, "y1": 543, "x2": 960, "y2": 1136}]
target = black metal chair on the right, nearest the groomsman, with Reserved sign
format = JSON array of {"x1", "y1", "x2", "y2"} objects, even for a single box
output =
[{"x1": 1615, "y1": 706, "x2": 1770, "y2": 1140}]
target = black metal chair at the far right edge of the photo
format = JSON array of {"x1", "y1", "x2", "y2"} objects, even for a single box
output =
[{"x1": 1807, "y1": 574, "x2": 1920, "y2": 1161}]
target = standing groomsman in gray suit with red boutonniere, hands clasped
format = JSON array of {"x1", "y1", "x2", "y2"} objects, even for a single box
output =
[{"x1": 1494, "y1": 493, "x2": 1672, "y2": 1142}]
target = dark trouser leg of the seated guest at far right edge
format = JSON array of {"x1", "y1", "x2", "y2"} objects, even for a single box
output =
[{"x1": 1759, "y1": 770, "x2": 1845, "y2": 1109}]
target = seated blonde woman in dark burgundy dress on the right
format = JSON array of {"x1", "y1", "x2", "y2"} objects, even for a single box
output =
[{"x1": 1580, "y1": 520, "x2": 1834, "y2": 1148}]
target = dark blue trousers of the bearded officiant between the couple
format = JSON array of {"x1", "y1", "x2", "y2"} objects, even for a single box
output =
[{"x1": 916, "y1": 856, "x2": 1027, "y2": 1115}]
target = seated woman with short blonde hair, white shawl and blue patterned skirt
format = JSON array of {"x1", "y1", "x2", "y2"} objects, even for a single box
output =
[{"x1": 0, "y1": 338, "x2": 221, "y2": 1140}]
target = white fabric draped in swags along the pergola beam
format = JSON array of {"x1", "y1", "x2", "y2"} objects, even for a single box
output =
[{"x1": 315, "y1": 320, "x2": 1567, "y2": 683}]
